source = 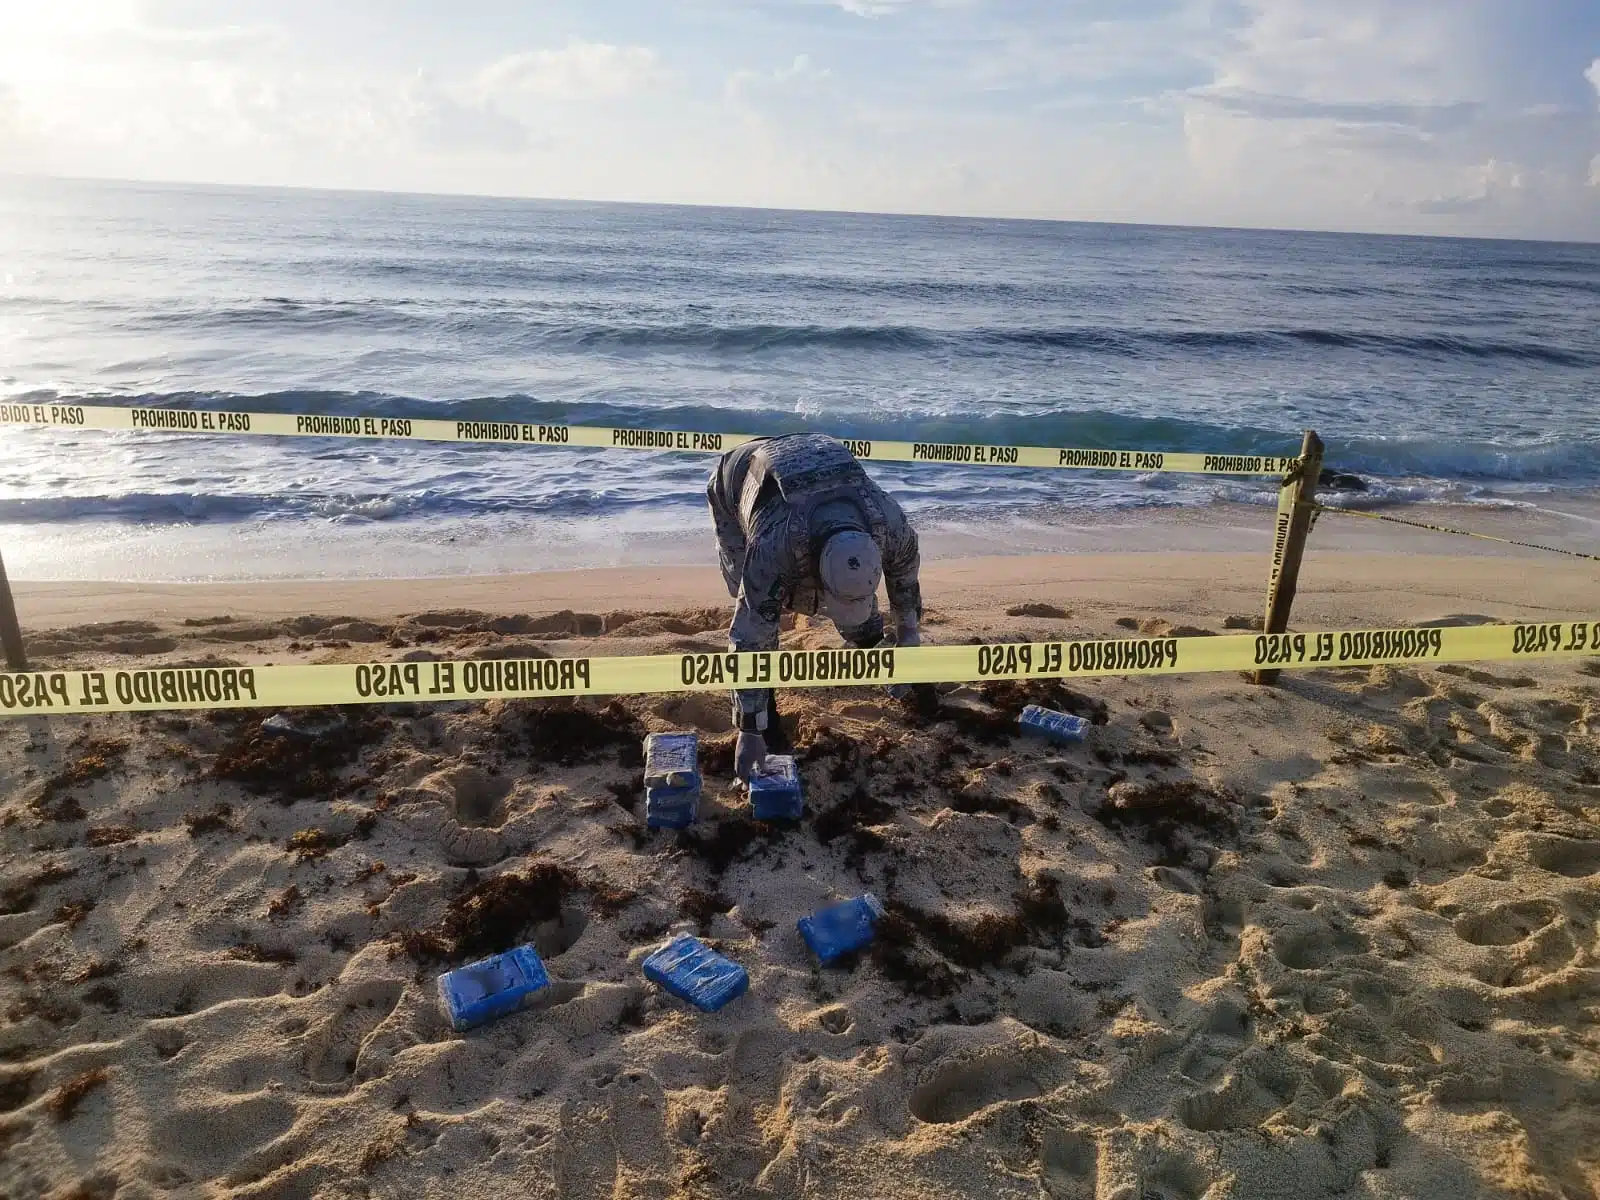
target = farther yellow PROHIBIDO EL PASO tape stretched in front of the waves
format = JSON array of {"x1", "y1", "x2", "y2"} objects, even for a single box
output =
[{"x1": 0, "y1": 403, "x2": 1299, "y2": 475}]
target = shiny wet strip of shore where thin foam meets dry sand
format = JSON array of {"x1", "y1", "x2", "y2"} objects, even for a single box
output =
[{"x1": 0, "y1": 494, "x2": 1600, "y2": 587}]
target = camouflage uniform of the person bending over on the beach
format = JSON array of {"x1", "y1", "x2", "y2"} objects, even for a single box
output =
[{"x1": 706, "y1": 434, "x2": 922, "y2": 728}]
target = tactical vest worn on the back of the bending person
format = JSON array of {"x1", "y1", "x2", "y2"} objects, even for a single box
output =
[{"x1": 739, "y1": 434, "x2": 888, "y2": 613}]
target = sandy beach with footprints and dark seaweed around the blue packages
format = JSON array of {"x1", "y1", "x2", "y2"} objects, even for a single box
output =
[{"x1": 0, "y1": 550, "x2": 1600, "y2": 1200}]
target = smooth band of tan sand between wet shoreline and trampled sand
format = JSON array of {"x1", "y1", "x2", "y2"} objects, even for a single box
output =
[{"x1": 13, "y1": 546, "x2": 1597, "y2": 632}]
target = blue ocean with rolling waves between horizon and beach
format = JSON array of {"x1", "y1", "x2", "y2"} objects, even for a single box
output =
[{"x1": 0, "y1": 178, "x2": 1600, "y2": 579}]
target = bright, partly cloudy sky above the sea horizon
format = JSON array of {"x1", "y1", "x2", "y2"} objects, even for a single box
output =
[{"x1": 0, "y1": 0, "x2": 1600, "y2": 240}]
